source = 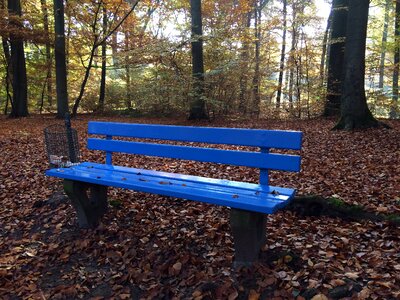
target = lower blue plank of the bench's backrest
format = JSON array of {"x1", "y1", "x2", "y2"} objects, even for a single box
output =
[{"x1": 87, "y1": 138, "x2": 300, "y2": 172}]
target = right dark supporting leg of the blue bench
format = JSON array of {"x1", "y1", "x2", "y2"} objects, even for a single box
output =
[{"x1": 231, "y1": 208, "x2": 266, "y2": 268}]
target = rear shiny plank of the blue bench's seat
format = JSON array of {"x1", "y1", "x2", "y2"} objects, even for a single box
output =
[{"x1": 79, "y1": 162, "x2": 294, "y2": 196}]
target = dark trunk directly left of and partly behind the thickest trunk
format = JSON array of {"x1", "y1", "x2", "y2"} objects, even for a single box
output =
[{"x1": 324, "y1": 0, "x2": 349, "y2": 117}]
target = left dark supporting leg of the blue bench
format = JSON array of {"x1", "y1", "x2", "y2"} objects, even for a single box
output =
[{"x1": 64, "y1": 179, "x2": 107, "y2": 228}]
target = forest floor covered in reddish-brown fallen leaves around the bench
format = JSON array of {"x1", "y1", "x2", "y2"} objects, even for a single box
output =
[{"x1": 0, "y1": 116, "x2": 400, "y2": 300}]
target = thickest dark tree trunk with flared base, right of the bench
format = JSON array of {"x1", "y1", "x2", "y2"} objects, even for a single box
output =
[{"x1": 335, "y1": 0, "x2": 379, "y2": 130}]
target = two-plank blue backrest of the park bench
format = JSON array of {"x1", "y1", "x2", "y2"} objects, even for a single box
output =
[{"x1": 88, "y1": 122, "x2": 302, "y2": 184}]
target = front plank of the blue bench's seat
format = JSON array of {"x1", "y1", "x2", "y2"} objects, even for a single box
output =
[{"x1": 46, "y1": 167, "x2": 296, "y2": 213}]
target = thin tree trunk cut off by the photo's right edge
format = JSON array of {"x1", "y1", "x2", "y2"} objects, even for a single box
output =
[{"x1": 389, "y1": 0, "x2": 400, "y2": 119}]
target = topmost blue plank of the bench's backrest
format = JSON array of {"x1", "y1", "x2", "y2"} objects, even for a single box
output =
[{"x1": 88, "y1": 122, "x2": 302, "y2": 150}]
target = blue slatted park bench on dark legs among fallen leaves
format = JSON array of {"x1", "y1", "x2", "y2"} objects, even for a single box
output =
[{"x1": 46, "y1": 122, "x2": 302, "y2": 264}]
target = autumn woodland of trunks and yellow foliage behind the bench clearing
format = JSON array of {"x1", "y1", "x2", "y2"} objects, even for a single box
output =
[{"x1": 0, "y1": 0, "x2": 400, "y2": 129}]
